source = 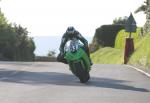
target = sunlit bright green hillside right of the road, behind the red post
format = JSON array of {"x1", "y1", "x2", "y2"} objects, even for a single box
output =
[{"x1": 91, "y1": 28, "x2": 150, "y2": 70}]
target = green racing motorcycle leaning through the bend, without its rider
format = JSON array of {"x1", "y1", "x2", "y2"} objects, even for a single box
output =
[{"x1": 64, "y1": 39, "x2": 91, "y2": 83}]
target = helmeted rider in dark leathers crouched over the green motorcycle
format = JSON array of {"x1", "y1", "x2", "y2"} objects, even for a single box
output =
[{"x1": 57, "y1": 26, "x2": 93, "y2": 65}]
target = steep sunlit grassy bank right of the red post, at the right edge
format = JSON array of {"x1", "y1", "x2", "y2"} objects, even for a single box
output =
[{"x1": 129, "y1": 35, "x2": 150, "y2": 71}]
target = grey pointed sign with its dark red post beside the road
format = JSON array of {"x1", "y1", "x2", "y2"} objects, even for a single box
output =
[{"x1": 124, "y1": 13, "x2": 136, "y2": 64}]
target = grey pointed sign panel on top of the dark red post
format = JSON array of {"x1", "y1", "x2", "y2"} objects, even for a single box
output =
[{"x1": 125, "y1": 13, "x2": 136, "y2": 33}]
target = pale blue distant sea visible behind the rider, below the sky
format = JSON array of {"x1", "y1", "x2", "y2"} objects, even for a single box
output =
[{"x1": 33, "y1": 36, "x2": 93, "y2": 56}]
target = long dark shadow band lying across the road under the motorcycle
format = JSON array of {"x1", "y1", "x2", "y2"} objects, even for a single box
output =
[{"x1": 0, "y1": 70, "x2": 149, "y2": 92}]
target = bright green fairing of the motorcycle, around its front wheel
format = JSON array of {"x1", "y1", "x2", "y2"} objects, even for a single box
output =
[{"x1": 65, "y1": 48, "x2": 90, "y2": 71}]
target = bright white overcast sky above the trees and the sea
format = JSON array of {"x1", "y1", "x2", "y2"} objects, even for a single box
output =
[{"x1": 0, "y1": 0, "x2": 146, "y2": 36}]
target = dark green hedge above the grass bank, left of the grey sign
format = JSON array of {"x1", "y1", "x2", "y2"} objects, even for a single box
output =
[{"x1": 89, "y1": 16, "x2": 127, "y2": 53}]
